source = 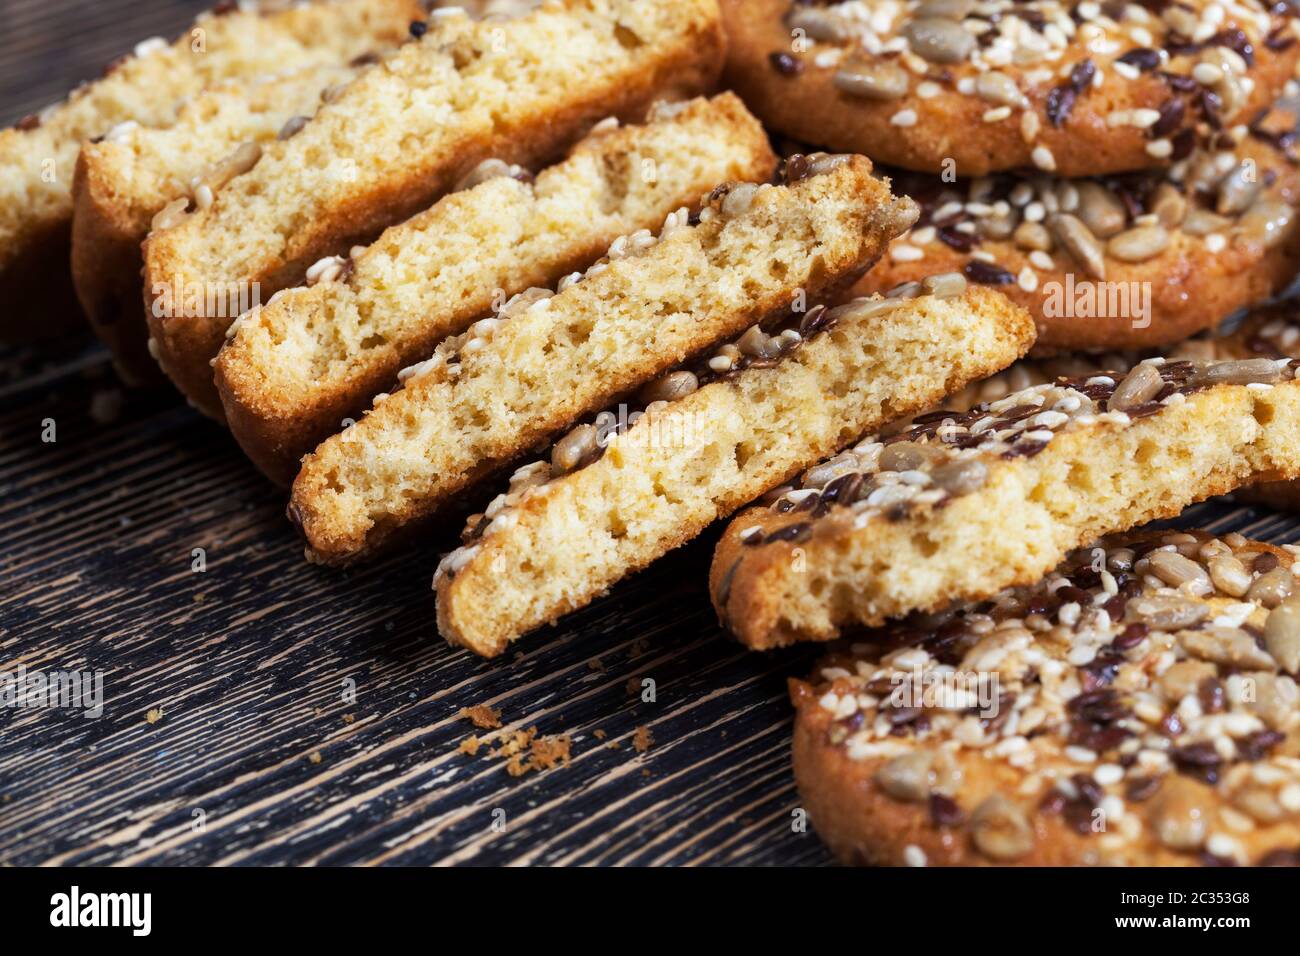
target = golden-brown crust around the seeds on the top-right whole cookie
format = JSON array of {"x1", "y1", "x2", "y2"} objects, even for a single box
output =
[{"x1": 723, "y1": 0, "x2": 1300, "y2": 177}]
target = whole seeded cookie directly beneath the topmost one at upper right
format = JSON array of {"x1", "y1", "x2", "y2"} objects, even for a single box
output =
[{"x1": 855, "y1": 126, "x2": 1300, "y2": 354}]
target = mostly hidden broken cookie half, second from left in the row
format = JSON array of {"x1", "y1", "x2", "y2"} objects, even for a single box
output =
[{"x1": 72, "y1": 64, "x2": 361, "y2": 385}]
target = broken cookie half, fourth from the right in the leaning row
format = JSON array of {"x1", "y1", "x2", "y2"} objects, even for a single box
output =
[{"x1": 215, "y1": 94, "x2": 776, "y2": 484}]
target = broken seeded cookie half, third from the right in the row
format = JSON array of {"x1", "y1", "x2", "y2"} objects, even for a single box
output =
[{"x1": 290, "y1": 156, "x2": 914, "y2": 563}]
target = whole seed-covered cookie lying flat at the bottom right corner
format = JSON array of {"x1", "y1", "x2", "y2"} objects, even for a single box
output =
[{"x1": 790, "y1": 532, "x2": 1300, "y2": 866}]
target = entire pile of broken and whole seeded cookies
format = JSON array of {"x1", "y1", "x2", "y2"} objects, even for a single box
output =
[{"x1": 10, "y1": 0, "x2": 1300, "y2": 864}]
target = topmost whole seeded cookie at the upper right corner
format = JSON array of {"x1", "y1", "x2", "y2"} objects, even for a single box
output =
[{"x1": 723, "y1": 0, "x2": 1300, "y2": 177}]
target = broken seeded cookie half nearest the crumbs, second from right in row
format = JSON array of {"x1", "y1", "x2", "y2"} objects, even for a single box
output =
[{"x1": 434, "y1": 273, "x2": 1034, "y2": 657}]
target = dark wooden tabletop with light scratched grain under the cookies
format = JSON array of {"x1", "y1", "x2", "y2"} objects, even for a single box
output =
[{"x1": 0, "y1": 0, "x2": 1300, "y2": 865}]
